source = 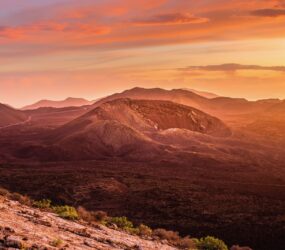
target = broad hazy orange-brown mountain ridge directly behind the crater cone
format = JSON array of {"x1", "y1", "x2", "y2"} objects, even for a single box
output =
[{"x1": 93, "y1": 88, "x2": 278, "y2": 118}]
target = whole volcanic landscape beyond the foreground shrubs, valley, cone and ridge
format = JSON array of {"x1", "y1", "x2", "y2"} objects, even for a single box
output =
[{"x1": 0, "y1": 88, "x2": 285, "y2": 250}]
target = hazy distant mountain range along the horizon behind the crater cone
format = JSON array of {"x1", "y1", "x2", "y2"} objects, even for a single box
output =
[{"x1": 18, "y1": 87, "x2": 282, "y2": 117}]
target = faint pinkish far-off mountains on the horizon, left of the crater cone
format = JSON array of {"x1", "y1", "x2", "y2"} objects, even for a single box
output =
[{"x1": 22, "y1": 97, "x2": 93, "y2": 110}]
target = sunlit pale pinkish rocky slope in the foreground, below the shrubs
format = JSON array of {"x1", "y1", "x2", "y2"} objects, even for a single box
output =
[{"x1": 0, "y1": 196, "x2": 176, "y2": 250}]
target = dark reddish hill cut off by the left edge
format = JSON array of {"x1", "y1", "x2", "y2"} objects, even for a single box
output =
[{"x1": 0, "y1": 103, "x2": 28, "y2": 128}]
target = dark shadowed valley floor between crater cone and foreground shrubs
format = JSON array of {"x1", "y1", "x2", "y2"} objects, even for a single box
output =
[{"x1": 0, "y1": 158, "x2": 285, "y2": 250}]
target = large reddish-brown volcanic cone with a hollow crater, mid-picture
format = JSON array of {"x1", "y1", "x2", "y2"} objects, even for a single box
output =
[{"x1": 22, "y1": 99, "x2": 231, "y2": 159}]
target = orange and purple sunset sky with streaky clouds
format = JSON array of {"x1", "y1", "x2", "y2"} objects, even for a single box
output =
[{"x1": 0, "y1": 0, "x2": 285, "y2": 107}]
